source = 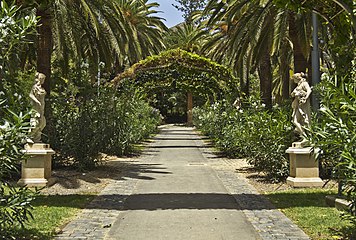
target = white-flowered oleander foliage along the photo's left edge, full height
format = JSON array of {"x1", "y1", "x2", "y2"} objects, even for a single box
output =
[{"x1": 0, "y1": 1, "x2": 37, "y2": 239}]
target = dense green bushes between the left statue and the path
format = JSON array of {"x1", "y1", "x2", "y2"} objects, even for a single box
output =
[{"x1": 50, "y1": 66, "x2": 160, "y2": 169}]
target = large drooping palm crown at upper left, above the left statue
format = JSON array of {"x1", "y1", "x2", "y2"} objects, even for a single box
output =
[{"x1": 17, "y1": 0, "x2": 166, "y2": 92}]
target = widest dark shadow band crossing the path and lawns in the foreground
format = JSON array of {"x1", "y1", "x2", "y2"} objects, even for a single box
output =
[{"x1": 34, "y1": 193, "x2": 334, "y2": 211}]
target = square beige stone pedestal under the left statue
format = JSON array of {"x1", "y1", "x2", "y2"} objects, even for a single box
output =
[{"x1": 18, "y1": 143, "x2": 54, "y2": 187}]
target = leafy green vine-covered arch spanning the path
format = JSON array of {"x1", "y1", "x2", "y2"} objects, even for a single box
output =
[{"x1": 113, "y1": 49, "x2": 238, "y2": 99}]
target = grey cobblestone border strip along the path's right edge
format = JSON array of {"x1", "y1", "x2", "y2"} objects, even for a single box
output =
[{"x1": 196, "y1": 137, "x2": 310, "y2": 240}]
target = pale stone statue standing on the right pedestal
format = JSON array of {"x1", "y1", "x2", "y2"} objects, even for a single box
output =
[{"x1": 291, "y1": 72, "x2": 312, "y2": 137}]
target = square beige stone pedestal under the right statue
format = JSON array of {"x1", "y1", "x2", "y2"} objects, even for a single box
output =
[{"x1": 286, "y1": 142, "x2": 324, "y2": 187}]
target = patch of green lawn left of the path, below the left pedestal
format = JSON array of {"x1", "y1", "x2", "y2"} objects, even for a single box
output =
[{"x1": 7, "y1": 195, "x2": 95, "y2": 240}]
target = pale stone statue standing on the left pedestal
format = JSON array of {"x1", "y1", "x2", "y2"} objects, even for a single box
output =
[{"x1": 30, "y1": 73, "x2": 46, "y2": 143}]
